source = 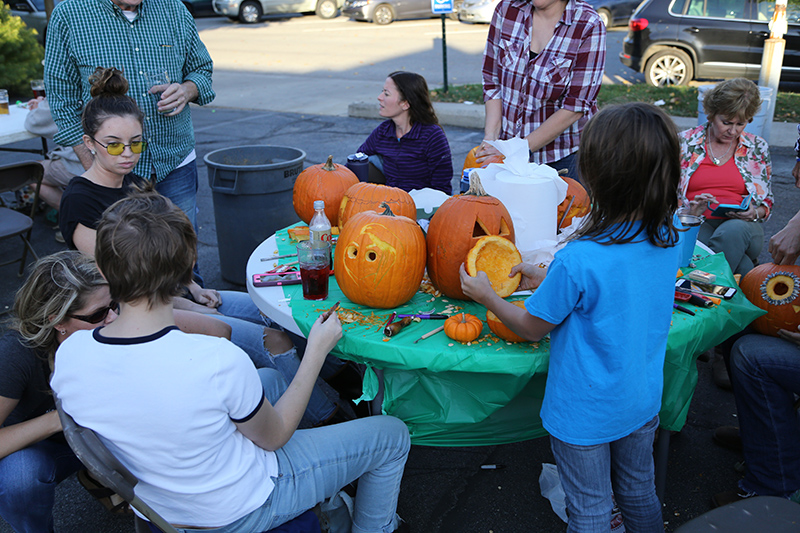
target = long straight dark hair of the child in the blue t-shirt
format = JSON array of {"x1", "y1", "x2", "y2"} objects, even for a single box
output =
[{"x1": 574, "y1": 102, "x2": 681, "y2": 247}]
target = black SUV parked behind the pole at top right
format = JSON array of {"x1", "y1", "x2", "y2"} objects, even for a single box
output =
[{"x1": 619, "y1": 0, "x2": 800, "y2": 86}]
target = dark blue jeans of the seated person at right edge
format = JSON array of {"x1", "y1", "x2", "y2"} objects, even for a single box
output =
[{"x1": 730, "y1": 335, "x2": 800, "y2": 496}]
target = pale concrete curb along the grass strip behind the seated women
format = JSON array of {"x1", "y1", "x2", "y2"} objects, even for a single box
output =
[{"x1": 347, "y1": 102, "x2": 797, "y2": 148}]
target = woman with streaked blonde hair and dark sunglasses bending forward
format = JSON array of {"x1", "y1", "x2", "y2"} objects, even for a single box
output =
[{"x1": 0, "y1": 251, "x2": 119, "y2": 532}]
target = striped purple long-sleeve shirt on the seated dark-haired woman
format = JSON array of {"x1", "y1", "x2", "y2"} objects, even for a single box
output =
[{"x1": 358, "y1": 120, "x2": 453, "y2": 194}]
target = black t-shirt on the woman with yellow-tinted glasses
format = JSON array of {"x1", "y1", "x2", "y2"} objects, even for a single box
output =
[{"x1": 58, "y1": 174, "x2": 141, "y2": 250}]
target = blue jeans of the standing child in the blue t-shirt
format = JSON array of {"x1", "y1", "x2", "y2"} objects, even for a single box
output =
[{"x1": 550, "y1": 416, "x2": 664, "y2": 533}]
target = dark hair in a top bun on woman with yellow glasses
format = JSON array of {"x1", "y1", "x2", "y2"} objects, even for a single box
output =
[{"x1": 81, "y1": 67, "x2": 144, "y2": 137}]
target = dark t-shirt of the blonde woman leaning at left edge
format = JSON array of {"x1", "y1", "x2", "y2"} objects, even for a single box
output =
[{"x1": 0, "y1": 331, "x2": 55, "y2": 426}]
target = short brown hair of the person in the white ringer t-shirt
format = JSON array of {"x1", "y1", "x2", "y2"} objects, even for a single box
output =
[{"x1": 95, "y1": 192, "x2": 197, "y2": 308}]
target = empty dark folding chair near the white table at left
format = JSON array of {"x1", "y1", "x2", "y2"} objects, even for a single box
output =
[{"x1": 0, "y1": 161, "x2": 44, "y2": 276}]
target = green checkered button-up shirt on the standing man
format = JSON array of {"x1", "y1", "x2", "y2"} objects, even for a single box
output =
[{"x1": 44, "y1": 0, "x2": 215, "y2": 181}]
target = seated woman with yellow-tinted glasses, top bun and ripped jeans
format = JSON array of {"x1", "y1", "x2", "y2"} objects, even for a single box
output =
[{"x1": 59, "y1": 68, "x2": 350, "y2": 427}]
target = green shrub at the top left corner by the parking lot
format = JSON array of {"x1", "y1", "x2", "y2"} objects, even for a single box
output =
[{"x1": 0, "y1": 2, "x2": 44, "y2": 96}]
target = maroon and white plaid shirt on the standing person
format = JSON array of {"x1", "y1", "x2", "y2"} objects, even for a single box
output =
[{"x1": 483, "y1": 0, "x2": 606, "y2": 164}]
